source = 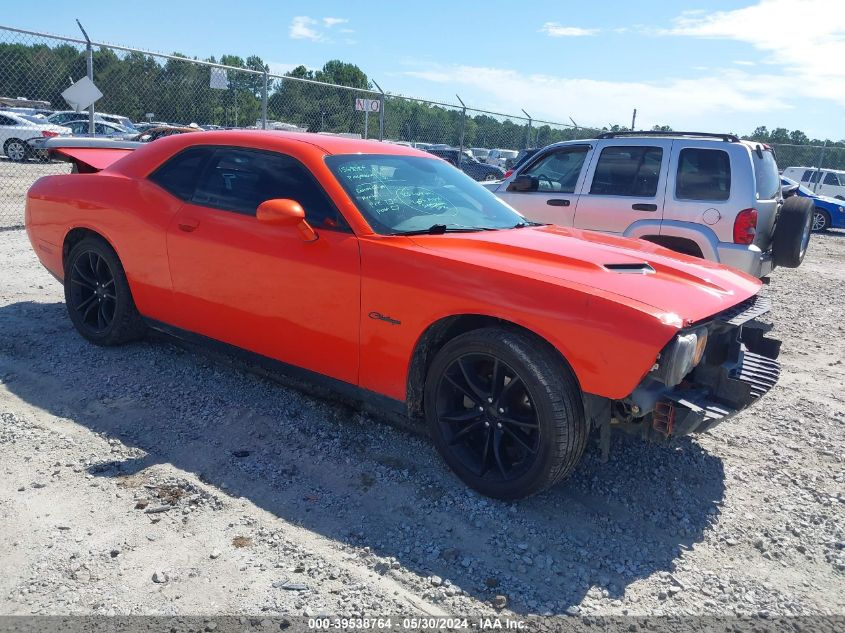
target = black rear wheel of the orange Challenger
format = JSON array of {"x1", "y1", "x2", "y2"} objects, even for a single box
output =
[{"x1": 64, "y1": 237, "x2": 146, "y2": 346}]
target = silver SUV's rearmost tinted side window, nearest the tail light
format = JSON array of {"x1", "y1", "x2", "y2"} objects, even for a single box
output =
[{"x1": 675, "y1": 147, "x2": 731, "y2": 200}]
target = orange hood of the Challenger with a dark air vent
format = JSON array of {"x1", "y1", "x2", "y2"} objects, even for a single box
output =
[{"x1": 413, "y1": 225, "x2": 762, "y2": 327}]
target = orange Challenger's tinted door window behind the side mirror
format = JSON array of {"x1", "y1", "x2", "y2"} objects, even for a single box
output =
[{"x1": 192, "y1": 148, "x2": 342, "y2": 228}]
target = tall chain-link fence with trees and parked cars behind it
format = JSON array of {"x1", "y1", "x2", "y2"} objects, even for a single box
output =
[{"x1": 0, "y1": 27, "x2": 845, "y2": 229}]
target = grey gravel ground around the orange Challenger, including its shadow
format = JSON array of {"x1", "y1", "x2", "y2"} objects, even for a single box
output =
[{"x1": 0, "y1": 226, "x2": 845, "y2": 616}]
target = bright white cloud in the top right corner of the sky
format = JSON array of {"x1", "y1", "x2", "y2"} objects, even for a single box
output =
[{"x1": 661, "y1": 0, "x2": 845, "y2": 105}]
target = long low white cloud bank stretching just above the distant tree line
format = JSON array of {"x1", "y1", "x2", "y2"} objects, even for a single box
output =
[{"x1": 405, "y1": 66, "x2": 792, "y2": 131}]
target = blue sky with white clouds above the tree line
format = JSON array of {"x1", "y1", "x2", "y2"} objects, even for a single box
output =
[{"x1": 8, "y1": 0, "x2": 845, "y2": 140}]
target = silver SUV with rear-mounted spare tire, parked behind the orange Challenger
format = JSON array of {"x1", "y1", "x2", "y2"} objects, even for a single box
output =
[{"x1": 487, "y1": 132, "x2": 812, "y2": 277}]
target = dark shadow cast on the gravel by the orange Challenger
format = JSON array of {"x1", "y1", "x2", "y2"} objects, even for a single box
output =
[{"x1": 0, "y1": 302, "x2": 725, "y2": 613}]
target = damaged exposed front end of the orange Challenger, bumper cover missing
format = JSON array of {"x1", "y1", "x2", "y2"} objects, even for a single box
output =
[{"x1": 614, "y1": 295, "x2": 780, "y2": 437}]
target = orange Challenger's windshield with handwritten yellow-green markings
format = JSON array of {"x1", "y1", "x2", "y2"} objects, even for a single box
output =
[{"x1": 326, "y1": 154, "x2": 527, "y2": 235}]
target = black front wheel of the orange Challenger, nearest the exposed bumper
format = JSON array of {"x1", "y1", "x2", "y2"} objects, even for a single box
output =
[{"x1": 424, "y1": 328, "x2": 587, "y2": 499}]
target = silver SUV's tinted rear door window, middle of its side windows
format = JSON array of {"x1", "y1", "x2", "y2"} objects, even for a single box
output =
[{"x1": 590, "y1": 145, "x2": 663, "y2": 198}]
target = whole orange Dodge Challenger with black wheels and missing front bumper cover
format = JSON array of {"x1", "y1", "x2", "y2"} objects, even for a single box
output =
[{"x1": 26, "y1": 131, "x2": 780, "y2": 499}]
